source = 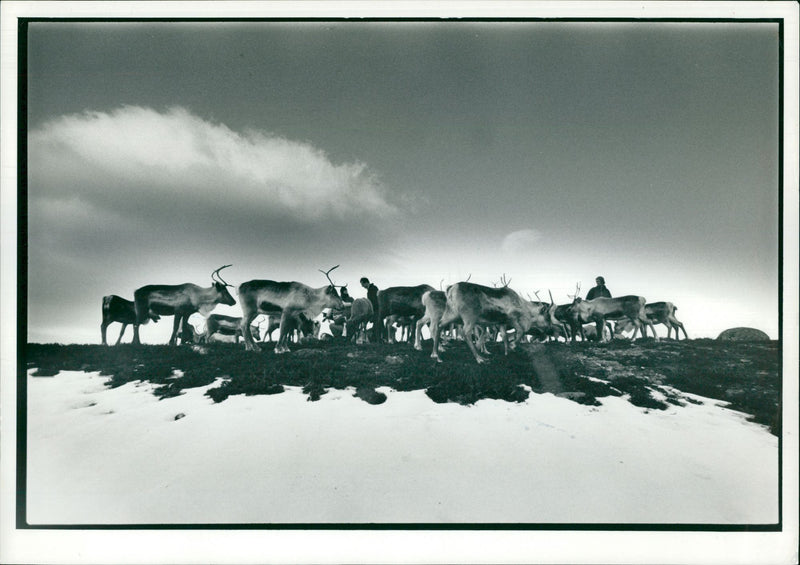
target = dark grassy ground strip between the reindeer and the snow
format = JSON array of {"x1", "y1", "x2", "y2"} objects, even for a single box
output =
[{"x1": 25, "y1": 339, "x2": 781, "y2": 434}]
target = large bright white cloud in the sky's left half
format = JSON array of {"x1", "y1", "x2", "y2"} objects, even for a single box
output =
[{"x1": 29, "y1": 106, "x2": 395, "y2": 221}]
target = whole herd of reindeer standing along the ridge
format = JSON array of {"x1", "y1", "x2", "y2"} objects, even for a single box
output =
[{"x1": 100, "y1": 265, "x2": 688, "y2": 363}]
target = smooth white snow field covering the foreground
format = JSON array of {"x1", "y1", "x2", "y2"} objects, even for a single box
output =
[{"x1": 27, "y1": 372, "x2": 778, "y2": 525}]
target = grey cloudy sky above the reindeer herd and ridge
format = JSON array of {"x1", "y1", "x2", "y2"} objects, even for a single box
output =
[{"x1": 27, "y1": 17, "x2": 779, "y2": 343}]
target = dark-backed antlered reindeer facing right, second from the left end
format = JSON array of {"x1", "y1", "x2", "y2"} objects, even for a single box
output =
[{"x1": 133, "y1": 265, "x2": 236, "y2": 345}]
